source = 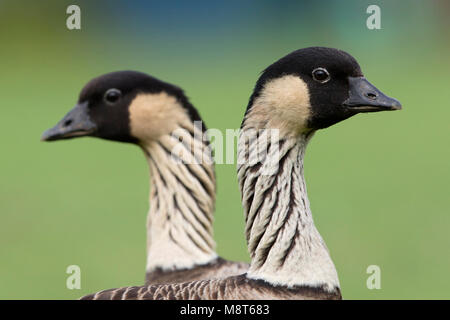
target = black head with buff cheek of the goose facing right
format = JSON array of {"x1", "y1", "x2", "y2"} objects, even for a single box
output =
[{"x1": 243, "y1": 47, "x2": 401, "y2": 134}]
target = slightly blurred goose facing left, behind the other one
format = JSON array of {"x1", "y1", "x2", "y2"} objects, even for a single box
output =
[{"x1": 42, "y1": 71, "x2": 248, "y2": 284}]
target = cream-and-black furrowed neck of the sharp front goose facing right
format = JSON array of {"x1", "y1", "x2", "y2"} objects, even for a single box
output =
[{"x1": 238, "y1": 126, "x2": 339, "y2": 291}]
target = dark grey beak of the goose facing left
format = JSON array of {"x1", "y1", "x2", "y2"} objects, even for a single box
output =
[{"x1": 41, "y1": 102, "x2": 97, "y2": 141}]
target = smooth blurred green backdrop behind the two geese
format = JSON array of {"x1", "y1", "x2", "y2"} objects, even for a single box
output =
[{"x1": 0, "y1": 0, "x2": 450, "y2": 299}]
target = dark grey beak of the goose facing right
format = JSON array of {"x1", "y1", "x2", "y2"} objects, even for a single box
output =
[{"x1": 344, "y1": 77, "x2": 402, "y2": 113}]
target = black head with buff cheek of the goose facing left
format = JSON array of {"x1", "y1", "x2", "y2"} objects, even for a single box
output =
[{"x1": 41, "y1": 71, "x2": 201, "y2": 144}]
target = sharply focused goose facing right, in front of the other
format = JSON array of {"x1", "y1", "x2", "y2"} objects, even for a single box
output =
[{"x1": 82, "y1": 47, "x2": 401, "y2": 300}]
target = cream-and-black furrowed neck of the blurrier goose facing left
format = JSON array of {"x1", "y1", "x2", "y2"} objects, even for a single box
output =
[{"x1": 142, "y1": 124, "x2": 217, "y2": 272}]
